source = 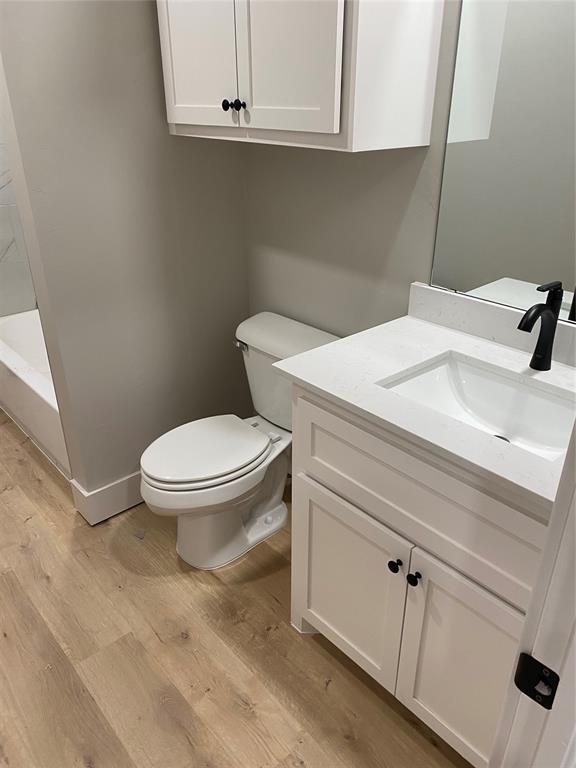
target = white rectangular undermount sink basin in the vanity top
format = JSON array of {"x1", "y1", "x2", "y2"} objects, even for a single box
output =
[{"x1": 377, "y1": 352, "x2": 576, "y2": 461}]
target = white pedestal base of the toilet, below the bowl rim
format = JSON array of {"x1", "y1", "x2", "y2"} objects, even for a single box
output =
[{"x1": 176, "y1": 453, "x2": 288, "y2": 571}]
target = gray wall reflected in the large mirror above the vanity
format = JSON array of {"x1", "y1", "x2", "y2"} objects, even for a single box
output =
[{"x1": 434, "y1": 0, "x2": 576, "y2": 291}]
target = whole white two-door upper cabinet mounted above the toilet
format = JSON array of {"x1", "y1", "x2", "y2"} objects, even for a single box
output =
[{"x1": 158, "y1": 0, "x2": 443, "y2": 152}]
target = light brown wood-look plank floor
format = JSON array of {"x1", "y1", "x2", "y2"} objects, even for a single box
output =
[{"x1": 0, "y1": 411, "x2": 467, "y2": 768}]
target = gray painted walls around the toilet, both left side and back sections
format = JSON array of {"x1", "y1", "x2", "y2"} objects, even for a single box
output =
[{"x1": 0, "y1": 0, "x2": 457, "y2": 498}]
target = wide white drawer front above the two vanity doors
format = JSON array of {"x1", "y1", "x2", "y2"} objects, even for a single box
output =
[{"x1": 294, "y1": 396, "x2": 546, "y2": 610}]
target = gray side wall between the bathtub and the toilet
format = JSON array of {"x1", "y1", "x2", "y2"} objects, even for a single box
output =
[{"x1": 0, "y1": 0, "x2": 249, "y2": 490}]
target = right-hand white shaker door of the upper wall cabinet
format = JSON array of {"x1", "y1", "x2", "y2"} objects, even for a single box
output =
[{"x1": 235, "y1": 0, "x2": 344, "y2": 133}]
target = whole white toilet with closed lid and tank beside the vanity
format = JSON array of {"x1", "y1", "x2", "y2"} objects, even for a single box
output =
[{"x1": 140, "y1": 312, "x2": 337, "y2": 569}]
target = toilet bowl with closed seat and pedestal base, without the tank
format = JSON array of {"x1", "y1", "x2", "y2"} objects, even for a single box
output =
[{"x1": 141, "y1": 415, "x2": 292, "y2": 570}]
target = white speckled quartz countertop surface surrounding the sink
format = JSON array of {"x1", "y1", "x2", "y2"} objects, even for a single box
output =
[{"x1": 276, "y1": 316, "x2": 576, "y2": 505}]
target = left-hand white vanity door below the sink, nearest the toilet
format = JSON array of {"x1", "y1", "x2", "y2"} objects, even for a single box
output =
[{"x1": 292, "y1": 475, "x2": 412, "y2": 693}]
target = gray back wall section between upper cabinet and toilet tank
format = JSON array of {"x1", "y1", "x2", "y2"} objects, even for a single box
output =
[{"x1": 246, "y1": 0, "x2": 458, "y2": 335}]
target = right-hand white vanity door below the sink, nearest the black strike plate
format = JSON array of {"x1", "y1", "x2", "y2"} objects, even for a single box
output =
[{"x1": 396, "y1": 548, "x2": 523, "y2": 768}]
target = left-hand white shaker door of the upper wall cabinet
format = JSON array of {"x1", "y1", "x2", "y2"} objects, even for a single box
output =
[{"x1": 158, "y1": 0, "x2": 238, "y2": 126}]
